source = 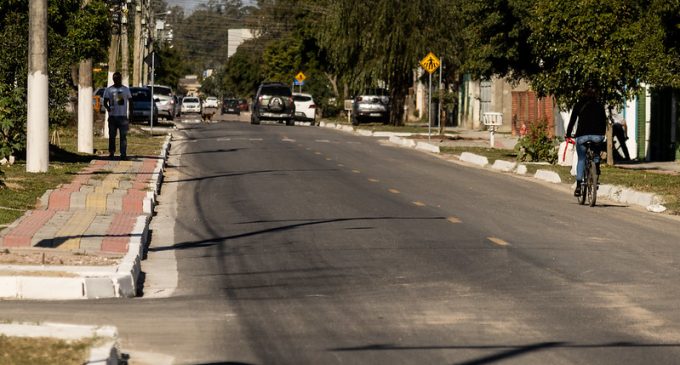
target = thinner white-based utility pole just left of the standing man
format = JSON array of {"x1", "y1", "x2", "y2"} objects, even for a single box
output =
[{"x1": 78, "y1": 0, "x2": 94, "y2": 154}]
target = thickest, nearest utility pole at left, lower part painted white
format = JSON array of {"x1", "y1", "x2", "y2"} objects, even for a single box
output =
[{"x1": 26, "y1": 0, "x2": 50, "y2": 172}]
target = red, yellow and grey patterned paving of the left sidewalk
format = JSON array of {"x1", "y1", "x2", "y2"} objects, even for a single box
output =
[{"x1": 0, "y1": 157, "x2": 160, "y2": 254}]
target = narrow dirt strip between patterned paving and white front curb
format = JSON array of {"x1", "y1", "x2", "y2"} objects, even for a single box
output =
[{"x1": 0, "y1": 249, "x2": 121, "y2": 266}]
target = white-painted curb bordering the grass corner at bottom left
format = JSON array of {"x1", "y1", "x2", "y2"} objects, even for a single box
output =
[{"x1": 0, "y1": 322, "x2": 119, "y2": 365}]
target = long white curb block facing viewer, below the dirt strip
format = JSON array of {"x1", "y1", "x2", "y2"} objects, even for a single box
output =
[{"x1": 17, "y1": 276, "x2": 85, "y2": 300}]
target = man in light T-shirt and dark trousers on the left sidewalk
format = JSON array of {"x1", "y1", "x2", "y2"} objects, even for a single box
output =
[{"x1": 103, "y1": 72, "x2": 132, "y2": 160}]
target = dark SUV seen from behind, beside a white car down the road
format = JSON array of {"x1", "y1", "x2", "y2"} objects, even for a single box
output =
[{"x1": 250, "y1": 82, "x2": 295, "y2": 125}]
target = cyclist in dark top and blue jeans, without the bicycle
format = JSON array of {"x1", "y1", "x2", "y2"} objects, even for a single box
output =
[{"x1": 566, "y1": 88, "x2": 607, "y2": 196}]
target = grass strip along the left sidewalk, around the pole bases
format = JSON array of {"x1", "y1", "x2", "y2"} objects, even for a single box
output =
[{"x1": 0, "y1": 124, "x2": 165, "y2": 228}]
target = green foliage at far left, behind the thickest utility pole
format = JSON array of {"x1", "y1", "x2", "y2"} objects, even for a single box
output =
[{"x1": 0, "y1": 0, "x2": 110, "y2": 156}]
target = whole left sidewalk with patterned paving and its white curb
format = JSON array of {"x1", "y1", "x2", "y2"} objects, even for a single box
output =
[{"x1": 0, "y1": 136, "x2": 170, "y2": 299}]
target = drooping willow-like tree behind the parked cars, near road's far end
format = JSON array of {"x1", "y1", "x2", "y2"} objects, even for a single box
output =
[{"x1": 319, "y1": 0, "x2": 462, "y2": 124}]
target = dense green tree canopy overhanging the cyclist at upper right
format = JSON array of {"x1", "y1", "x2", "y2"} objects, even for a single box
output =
[{"x1": 463, "y1": 0, "x2": 680, "y2": 107}]
